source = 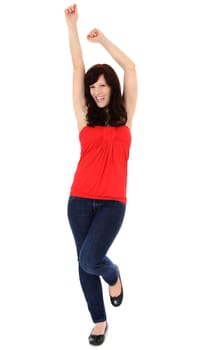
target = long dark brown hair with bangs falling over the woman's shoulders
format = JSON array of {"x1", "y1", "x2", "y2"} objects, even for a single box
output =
[{"x1": 85, "y1": 64, "x2": 127, "y2": 126}]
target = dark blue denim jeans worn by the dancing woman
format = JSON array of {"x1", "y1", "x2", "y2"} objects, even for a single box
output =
[{"x1": 68, "y1": 196, "x2": 126, "y2": 323}]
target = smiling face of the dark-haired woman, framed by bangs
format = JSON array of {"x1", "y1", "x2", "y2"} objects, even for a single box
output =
[{"x1": 89, "y1": 74, "x2": 111, "y2": 108}]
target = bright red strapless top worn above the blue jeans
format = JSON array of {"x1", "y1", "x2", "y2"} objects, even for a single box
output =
[{"x1": 70, "y1": 125, "x2": 131, "y2": 203}]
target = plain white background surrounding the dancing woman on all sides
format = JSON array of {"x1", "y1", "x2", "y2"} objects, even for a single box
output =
[{"x1": 0, "y1": 0, "x2": 200, "y2": 350}]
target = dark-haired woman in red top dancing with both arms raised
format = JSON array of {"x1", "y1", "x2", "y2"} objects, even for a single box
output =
[{"x1": 65, "y1": 4, "x2": 137, "y2": 345}]
